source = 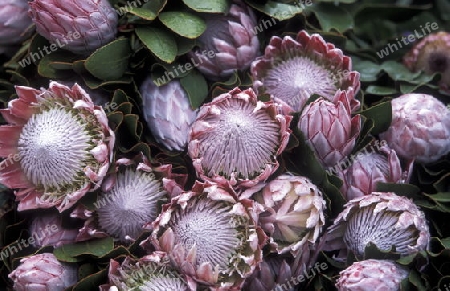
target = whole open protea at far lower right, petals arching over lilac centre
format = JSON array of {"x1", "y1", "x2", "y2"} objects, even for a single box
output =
[{"x1": 324, "y1": 192, "x2": 430, "y2": 258}]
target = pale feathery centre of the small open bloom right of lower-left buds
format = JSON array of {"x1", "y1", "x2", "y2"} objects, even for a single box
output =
[{"x1": 97, "y1": 168, "x2": 167, "y2": 241}]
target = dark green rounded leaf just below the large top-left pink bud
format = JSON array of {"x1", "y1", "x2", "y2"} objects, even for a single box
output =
[{"x1": 85, "y1": 38, "x2": 131, "y2": 81}]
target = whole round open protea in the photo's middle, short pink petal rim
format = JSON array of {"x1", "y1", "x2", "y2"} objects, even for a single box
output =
[{"x1": 188, "y1": 88, "x2": 292, "y2": 187}]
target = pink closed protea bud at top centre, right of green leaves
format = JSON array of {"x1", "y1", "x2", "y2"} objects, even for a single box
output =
[{"x1": 189, "y1": 0, "x2": 260, "y2": 80}]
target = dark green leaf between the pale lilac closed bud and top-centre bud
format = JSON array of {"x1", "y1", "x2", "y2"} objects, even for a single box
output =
[{"x1": 180, "y1": 70, "x2": 208, "y2": 109}]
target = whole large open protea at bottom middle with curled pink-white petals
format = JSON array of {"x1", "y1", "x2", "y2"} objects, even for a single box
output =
[{"x1": 141, "y1": 182, "x2": 266, "y2": 290}]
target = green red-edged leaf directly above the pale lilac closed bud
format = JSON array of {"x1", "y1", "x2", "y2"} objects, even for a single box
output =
[{"x1": 136, "y1": 27, "x2": 178, "y2": 64}]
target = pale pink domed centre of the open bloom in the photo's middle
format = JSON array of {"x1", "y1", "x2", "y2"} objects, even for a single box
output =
[{"x1": 199, "y1": 99, "x2": 280, "y2": 179}]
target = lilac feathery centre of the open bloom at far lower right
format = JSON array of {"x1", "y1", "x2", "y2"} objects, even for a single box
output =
[{"x1": 344, "y1": 205, "x2": 419, "y2": 258}]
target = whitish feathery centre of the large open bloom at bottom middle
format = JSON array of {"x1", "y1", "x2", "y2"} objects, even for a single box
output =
[{"x1": 169, "y1": 199, "x2": 247, "y2": 269}]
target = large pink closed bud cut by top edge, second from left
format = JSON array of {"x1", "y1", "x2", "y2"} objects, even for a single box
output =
[{"x1": 29, "y1": 0, "x2": 118, "y2": 55}]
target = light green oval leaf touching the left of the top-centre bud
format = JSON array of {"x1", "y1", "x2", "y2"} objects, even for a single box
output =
[{"x1": 159, "y1": 11, "x2": 206, "y2": 39}]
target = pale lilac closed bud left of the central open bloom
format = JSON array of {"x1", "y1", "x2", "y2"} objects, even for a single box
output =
[{"x1": 140, "y1": 77, "x2": 197, "y2": 151}]
